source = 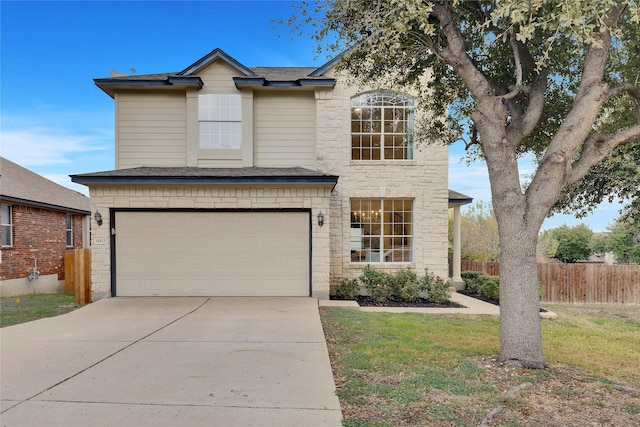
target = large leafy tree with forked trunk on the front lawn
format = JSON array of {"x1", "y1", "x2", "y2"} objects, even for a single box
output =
[{"x1": 290, "y1": 0, "x2": 640, "y2": 368}]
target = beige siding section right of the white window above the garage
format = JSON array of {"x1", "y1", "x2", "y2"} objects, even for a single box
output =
[{"x1": 254, "y1": 92, "x2": 316, "y2": 169}]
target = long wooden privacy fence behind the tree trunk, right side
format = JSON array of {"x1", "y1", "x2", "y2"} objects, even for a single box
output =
[{"x1": 461, "y1": 261, "x2": 640, "y2": 304}]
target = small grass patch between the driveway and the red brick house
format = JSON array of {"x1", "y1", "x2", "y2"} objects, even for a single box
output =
[{"x1": 0, "y1": 293, "x2": 78, "y2": 327}]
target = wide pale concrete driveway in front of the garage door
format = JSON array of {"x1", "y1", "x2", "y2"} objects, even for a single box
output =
[{"x1": 0, "y1": 297, "x2": 342, "y2": 427}]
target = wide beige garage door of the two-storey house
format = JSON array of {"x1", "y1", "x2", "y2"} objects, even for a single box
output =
[{"x1": 115, "y1": 211, "x2": 309, "y2": 296}]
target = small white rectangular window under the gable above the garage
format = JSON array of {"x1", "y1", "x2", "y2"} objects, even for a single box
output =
[{"x1": 198, "y1": 94, "x2": 242, "y2": 149}]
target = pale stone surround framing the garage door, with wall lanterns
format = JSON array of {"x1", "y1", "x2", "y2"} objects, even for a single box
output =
[{"x1": 90, "y1": 184, "x2": 332, "y2": 301}]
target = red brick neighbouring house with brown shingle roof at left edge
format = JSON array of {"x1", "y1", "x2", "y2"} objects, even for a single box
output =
[{"x1": 0, "y1": 157, "x2": 91, "y2": 296}]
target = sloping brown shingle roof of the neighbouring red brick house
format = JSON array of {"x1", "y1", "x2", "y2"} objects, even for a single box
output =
[{"x1": 0, "y1": 157, "x2": 91, "y2": 214}]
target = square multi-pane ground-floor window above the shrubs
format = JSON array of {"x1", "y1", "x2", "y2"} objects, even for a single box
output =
[{"x1": 349, "y1": 199, "x2": 413, "y2": 263}]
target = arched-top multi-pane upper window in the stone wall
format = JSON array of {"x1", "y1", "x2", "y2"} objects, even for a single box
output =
[{"x1": 351, "y1": 92, "x2": 414, "y2": 160}]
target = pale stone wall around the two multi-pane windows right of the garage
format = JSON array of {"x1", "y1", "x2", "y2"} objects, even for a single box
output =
[{"x1": 316, "y1": 77, "x2": 449, "y2": 291}]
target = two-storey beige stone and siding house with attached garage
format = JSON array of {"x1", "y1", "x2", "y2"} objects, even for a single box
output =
[{"x1": 72, "y1": 49, "x2": 471, "y2": 299}]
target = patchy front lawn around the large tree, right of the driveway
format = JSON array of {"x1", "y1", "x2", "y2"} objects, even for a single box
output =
[{"x1": 321, "y1": 306, "x2": 640, "y2": 426}]
